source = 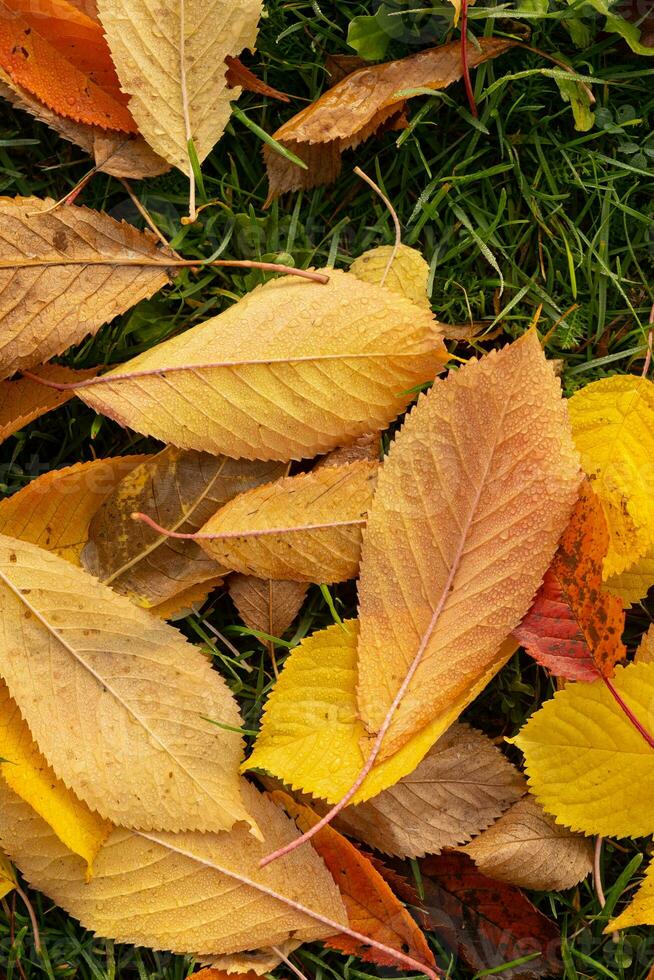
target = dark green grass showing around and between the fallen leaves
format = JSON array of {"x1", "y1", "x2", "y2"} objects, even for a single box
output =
[{"x1": 0, "y1": 0, "x2": 654, "y2": 980}]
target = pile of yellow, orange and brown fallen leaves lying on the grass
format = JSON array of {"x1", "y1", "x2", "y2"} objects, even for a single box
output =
[{"x1": 0, "y1": 0, "x2": 654, "y2": 977}]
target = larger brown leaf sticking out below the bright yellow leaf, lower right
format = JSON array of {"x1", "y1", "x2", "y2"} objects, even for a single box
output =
[{"x1": 334, "y1": 724, "x2": 526, "y2": 858}]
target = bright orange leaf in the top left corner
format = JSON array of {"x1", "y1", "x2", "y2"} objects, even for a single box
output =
[{"x1": 0, "y1": 0, "x2": 137, "y2": 133}]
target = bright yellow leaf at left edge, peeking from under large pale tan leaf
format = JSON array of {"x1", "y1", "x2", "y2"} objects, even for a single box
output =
[{"x1": 0, "y1": 681, "x2": 113, "y2": 871}]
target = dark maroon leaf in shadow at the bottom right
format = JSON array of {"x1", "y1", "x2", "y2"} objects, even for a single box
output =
[{"x1": 420, "y1": 852, "x2": 561, "y2": 980}]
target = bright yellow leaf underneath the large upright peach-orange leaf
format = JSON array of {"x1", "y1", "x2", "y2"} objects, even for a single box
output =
[{"x1": 243, "y1": 620, "x2": 515, "y2": 803}]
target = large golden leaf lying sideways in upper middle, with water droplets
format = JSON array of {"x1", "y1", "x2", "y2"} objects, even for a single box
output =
[{"x1": 79, "y1": 270, "x2": 446, "y2": 460}]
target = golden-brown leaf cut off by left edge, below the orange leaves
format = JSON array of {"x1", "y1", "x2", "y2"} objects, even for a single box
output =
[{"x1": 0, "y1": 197, "x2": 172, "y2": 378}]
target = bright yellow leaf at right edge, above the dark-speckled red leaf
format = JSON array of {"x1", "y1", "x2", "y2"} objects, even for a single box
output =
[{"x1": 569, "y1": 375, "x2": 654, "y2": 580}]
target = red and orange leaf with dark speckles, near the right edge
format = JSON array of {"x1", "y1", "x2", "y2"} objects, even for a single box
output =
[{"x1": 514, "y1": 482, "x2": 627, "y2": 681}]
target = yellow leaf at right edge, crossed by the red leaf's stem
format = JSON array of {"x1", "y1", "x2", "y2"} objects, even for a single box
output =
[{"x1": 512, "y1": 663, "x2": 654, "y2": 837}]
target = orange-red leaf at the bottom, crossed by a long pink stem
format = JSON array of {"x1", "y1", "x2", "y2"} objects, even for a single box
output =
[{"x1": 272, "y1": 791, "x2": 435, "y2": 968}]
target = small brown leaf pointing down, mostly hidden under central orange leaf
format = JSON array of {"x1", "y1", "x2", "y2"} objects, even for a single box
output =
[{"x1": 229, "y1": 573, "x2": 308, "y2": 637}]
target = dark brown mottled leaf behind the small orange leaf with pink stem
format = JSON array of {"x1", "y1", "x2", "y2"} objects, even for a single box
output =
[{"x1": 82, "y1": 446, "x2": 284, "y2": 608}]
